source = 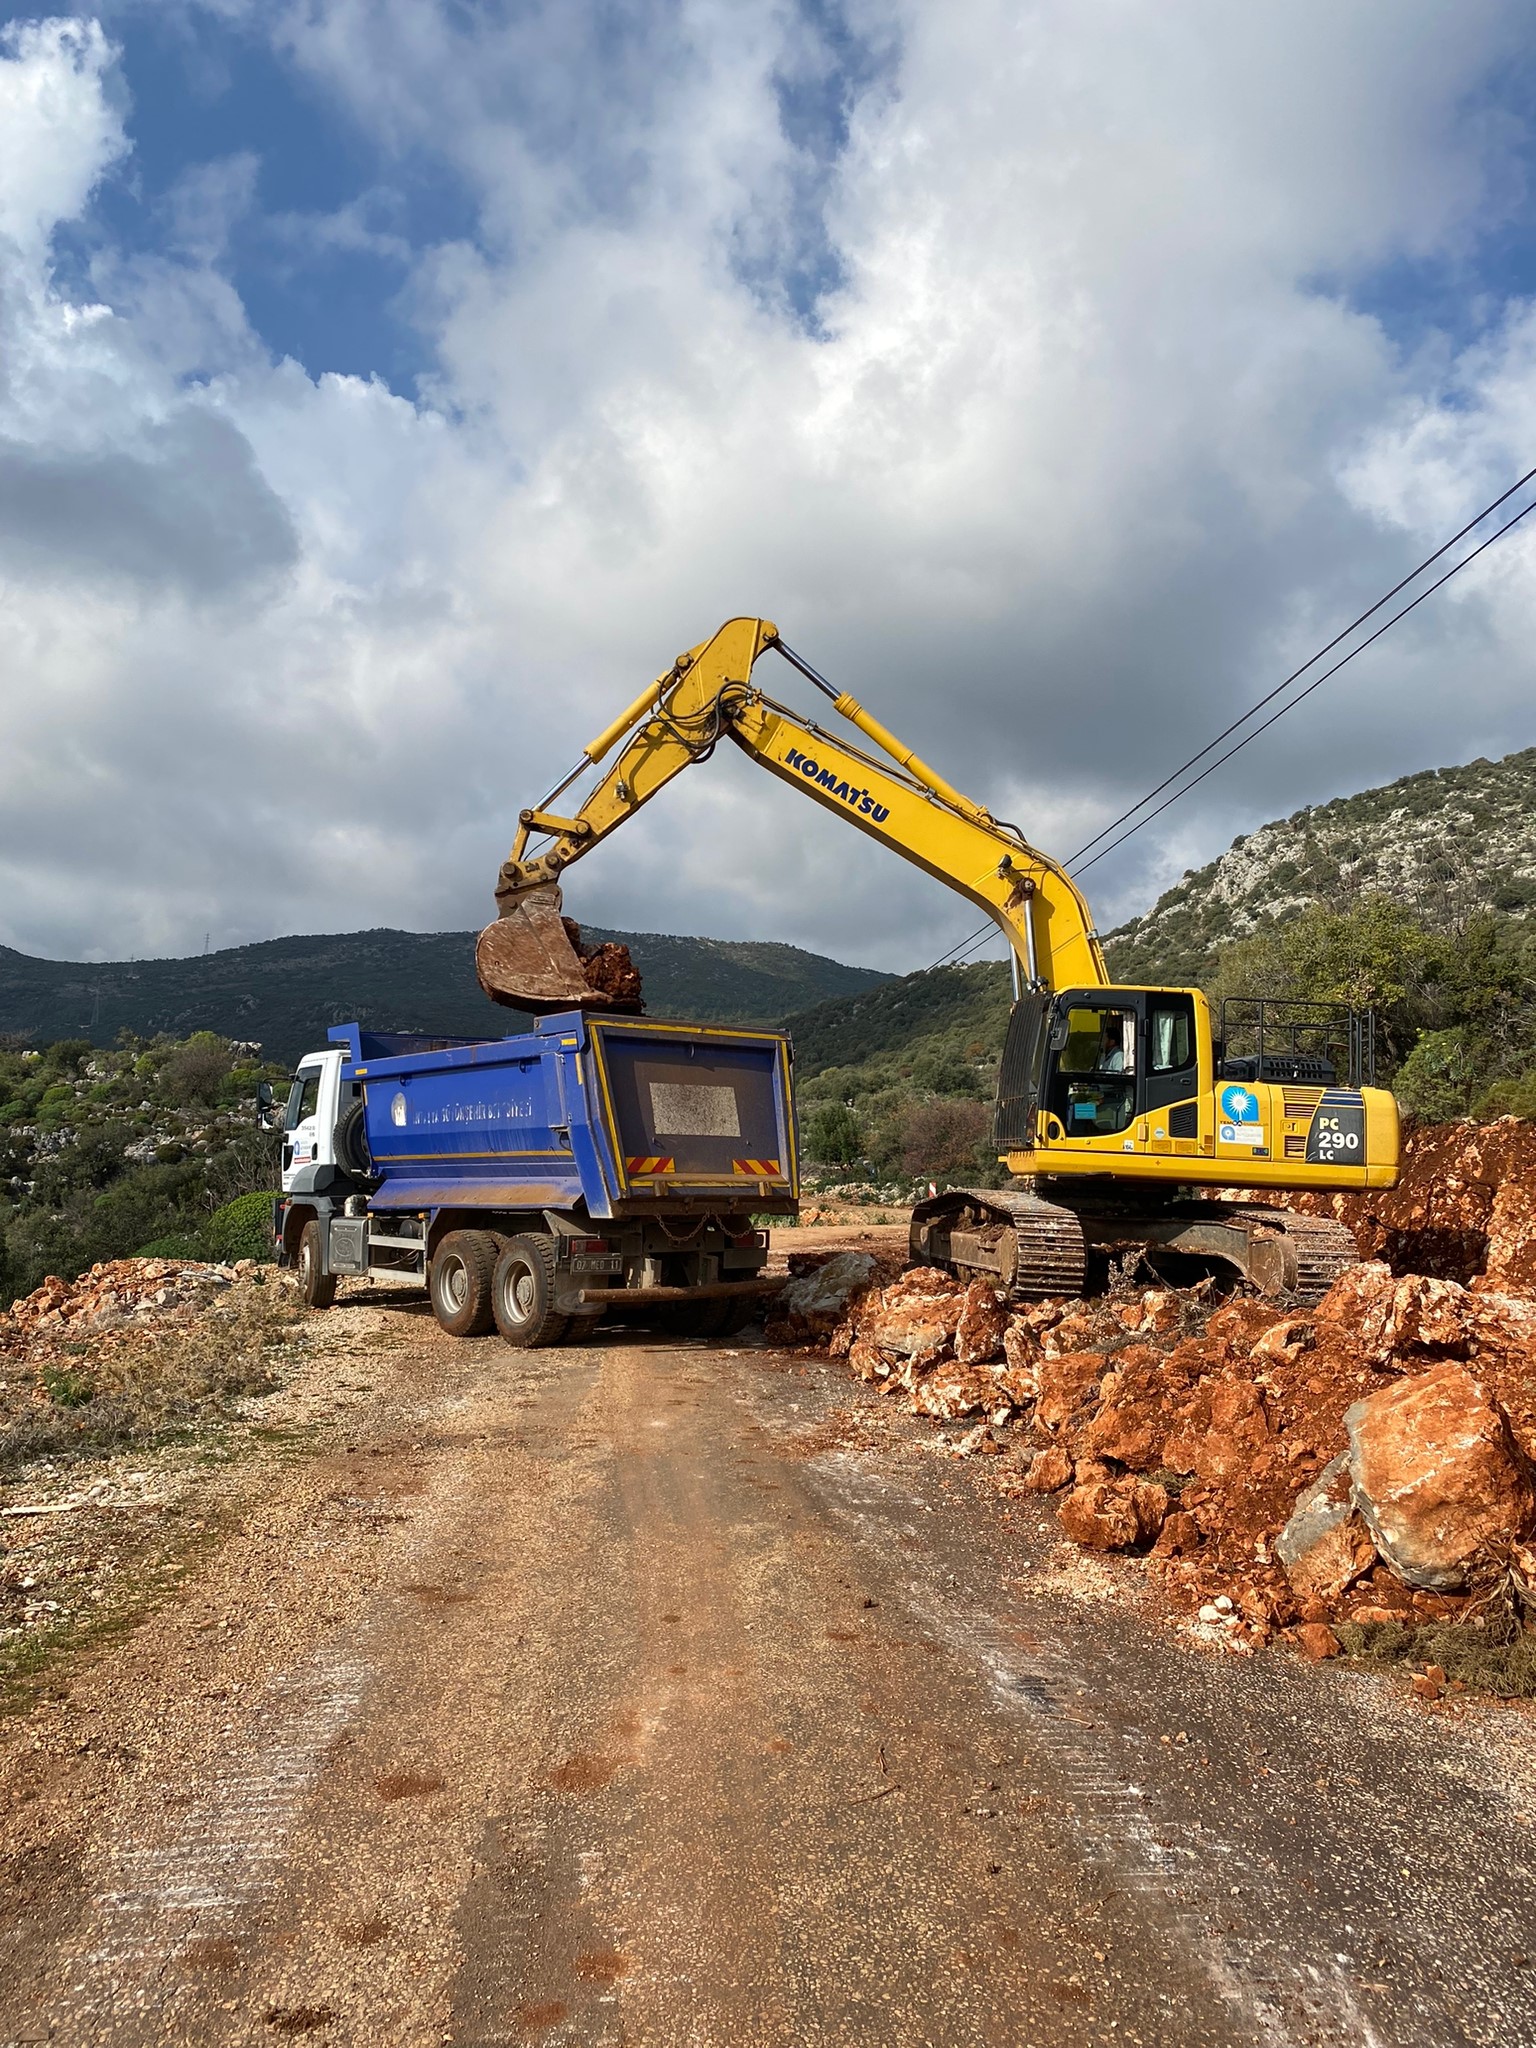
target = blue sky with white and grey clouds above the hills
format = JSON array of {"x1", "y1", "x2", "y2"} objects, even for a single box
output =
[{"x1": 0, "y1": 0, "x2": 1536, "y2": 969}]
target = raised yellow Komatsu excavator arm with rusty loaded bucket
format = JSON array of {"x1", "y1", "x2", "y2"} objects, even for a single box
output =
[{"x1": 475, "y1": 618, "x2": 1108, "y2": 1010}]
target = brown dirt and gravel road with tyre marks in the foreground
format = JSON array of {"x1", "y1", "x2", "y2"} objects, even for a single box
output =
[{"x1": 0, "y1": 1305, "x2": 1536, "y2": 2048}]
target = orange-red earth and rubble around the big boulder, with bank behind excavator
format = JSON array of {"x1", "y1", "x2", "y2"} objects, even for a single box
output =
[{"x1": 786, "y1": 1118, "x2": 1536, "y2": 1692}]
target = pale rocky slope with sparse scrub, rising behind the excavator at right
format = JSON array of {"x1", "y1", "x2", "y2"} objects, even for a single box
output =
[{"x1": 1104, "y1": 748, "x2": 1536, "y2": 985}]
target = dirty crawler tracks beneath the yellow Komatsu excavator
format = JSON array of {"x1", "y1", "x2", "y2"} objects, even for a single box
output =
[{"x1": 909, "y1": 1188, "x2": 1360, "y2": 1303}]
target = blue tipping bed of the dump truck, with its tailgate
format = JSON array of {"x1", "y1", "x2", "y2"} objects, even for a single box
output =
[{"x1": 330, "y1": 1010, "x2": 799, "y2": 1219}]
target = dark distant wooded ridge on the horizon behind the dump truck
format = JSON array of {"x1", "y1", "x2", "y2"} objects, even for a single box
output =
[{"x1": 0, "y1": 926, "x2": 891, "y2": 1063}]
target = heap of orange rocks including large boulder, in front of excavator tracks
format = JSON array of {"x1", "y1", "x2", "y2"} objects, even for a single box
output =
[{"x1": 829, "y1": 1260, "x2": 1536, "y2": 1655}]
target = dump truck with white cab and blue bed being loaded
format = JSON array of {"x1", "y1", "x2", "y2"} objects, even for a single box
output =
[{"x1": 272, "y1": 1010, "x2": 799, "y2": 1348}]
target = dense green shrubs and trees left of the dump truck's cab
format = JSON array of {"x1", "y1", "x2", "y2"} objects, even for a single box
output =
[{"x1": 0, "y1": 1032, "x2": 283, "y2": 1303}]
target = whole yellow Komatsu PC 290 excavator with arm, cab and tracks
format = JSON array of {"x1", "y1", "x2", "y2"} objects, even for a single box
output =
[{"x1": 475, "y1": 618, "x2": 1399, "y2": 1300}]
